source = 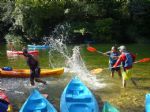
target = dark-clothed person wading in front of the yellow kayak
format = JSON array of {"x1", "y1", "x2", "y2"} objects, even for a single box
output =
[{"x1": 22, "y1": 48, "x2": 46, "y2": 86}]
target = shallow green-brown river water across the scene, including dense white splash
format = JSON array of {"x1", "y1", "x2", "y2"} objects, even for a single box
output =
[{"x1": 0, "y1": 44, "x2": 150, "y2": 112}]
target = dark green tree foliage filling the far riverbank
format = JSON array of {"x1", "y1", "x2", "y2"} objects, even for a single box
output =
[{"x1": 0, "y1": 0, "x2": 150, "y2": 42}]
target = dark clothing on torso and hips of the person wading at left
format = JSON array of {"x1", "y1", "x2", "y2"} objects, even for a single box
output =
[{"x1": 27, "y1": 54, "x2": 40, "y2": 79}]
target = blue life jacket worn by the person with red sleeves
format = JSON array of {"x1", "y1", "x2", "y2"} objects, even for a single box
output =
[{"x1": 123, "y1": 52, "x2": 133, "y2": 68}]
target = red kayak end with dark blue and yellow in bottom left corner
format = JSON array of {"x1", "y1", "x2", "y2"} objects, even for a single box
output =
[{"x1": 0, "y1": 89, "x2": 12, "y2": 112}]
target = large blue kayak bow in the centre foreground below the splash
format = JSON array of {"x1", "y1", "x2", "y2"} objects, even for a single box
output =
[{"x1": 60, "y1": 77, "x2": 100, "y2": 112}]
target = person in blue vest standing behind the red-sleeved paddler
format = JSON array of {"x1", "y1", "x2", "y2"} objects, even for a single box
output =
[{"x1": 104, "y1": 46, "x2": 121, "y2": 78}]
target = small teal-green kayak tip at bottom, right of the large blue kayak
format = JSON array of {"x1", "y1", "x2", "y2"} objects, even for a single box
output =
[{"x1": 102, "y1": 102, "x2": 119, "y2": 112}]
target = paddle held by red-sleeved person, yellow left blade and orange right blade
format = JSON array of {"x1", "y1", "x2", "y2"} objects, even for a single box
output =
[{"x1": 91, "y1": 58, "x2": 150, "y2": 74}]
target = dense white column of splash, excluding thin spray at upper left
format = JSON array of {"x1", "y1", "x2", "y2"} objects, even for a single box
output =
[{"x1": 67, "y1": 46, "x2": 105, "y2": 89}]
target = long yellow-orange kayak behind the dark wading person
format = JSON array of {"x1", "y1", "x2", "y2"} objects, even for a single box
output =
[{"x1": 0, "y1": 68, "x2": 64, "y2": 78}]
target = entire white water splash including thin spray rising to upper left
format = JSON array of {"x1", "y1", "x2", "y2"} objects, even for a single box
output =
[{"x1": 45, "y1": 24, "x2": 105, "y2": 89}]
